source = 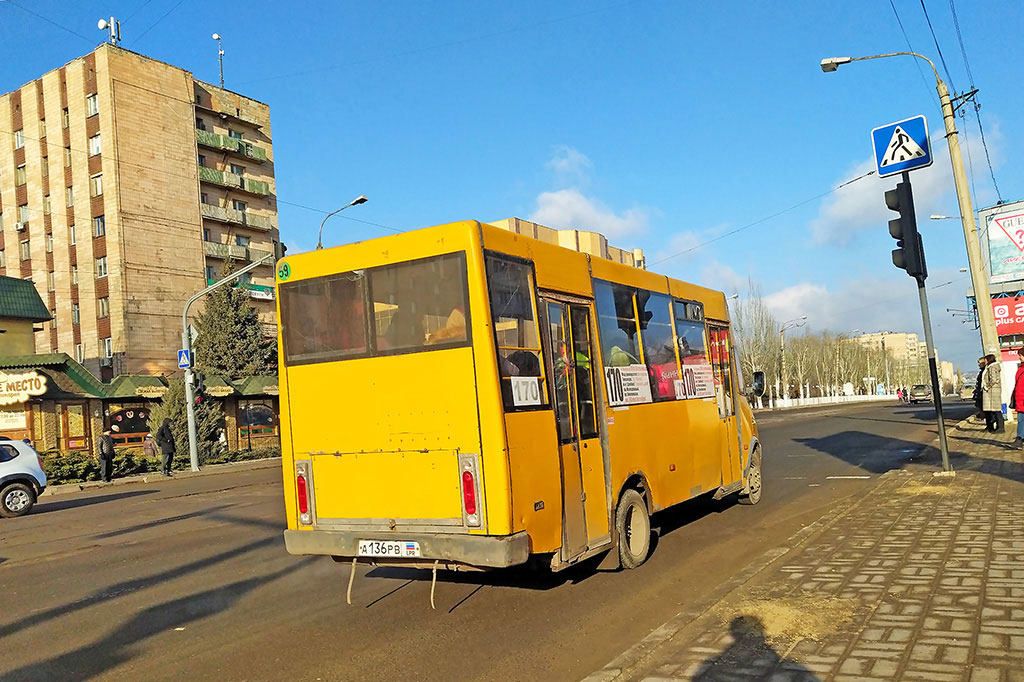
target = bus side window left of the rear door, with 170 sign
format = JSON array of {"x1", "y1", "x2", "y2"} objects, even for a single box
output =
[{"x1": 486, "y1": 254, "x2": 548, "y2": 405}]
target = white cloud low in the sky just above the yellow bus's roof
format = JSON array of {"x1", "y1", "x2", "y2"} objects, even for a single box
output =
[{"x1": 527, "y1": 188, "x2": 647, "y2": 240}]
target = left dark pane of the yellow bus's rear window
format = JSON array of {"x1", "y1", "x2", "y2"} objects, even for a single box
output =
[{"x1": 281, "y1": 272, "x2": 368, "y2": 365}]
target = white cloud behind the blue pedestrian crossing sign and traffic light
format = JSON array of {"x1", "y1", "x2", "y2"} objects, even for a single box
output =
[{"x1": 811, "y1": 136, "x2": 953, "y2": 245}]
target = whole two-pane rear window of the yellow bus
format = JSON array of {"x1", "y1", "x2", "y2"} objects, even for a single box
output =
[{"x1": 281, "y1": 252, "x2": 470, "y2": 366}]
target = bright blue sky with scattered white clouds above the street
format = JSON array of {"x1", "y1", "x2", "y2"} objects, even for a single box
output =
[{"x1": 0, "y1": 0, "x2": 1024, "y2": 369}]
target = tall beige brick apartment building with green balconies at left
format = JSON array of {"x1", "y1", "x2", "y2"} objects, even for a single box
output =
[{"x1": 0, "y1": 44, "x2": 279, "y2": 381}]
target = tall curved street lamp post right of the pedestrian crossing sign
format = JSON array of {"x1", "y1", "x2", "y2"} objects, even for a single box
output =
[{"x1": 821, "y1": 52, "x2": 999, "y2": 356}]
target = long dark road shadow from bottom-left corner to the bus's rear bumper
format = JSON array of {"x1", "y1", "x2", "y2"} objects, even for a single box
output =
[{"x1": 0, "y1": 557, "x2": 315, "y2": 682}]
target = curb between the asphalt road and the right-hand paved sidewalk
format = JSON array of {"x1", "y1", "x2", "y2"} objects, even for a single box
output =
[{"x1": 581, "y1": 409, "x2": 970, "y2": 682}]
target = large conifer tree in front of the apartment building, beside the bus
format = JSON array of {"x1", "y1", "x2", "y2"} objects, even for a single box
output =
[{"x1": 195, "y1": 261, "x2": 278, "y2": 379}]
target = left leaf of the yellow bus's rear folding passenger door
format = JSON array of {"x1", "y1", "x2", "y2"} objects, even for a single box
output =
[{"x1": 545, "y1": 301, "x2": 587, "y2": 561}]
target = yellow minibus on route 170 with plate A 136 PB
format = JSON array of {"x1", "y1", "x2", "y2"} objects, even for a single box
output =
[{"x1": 276, "y1": 221, "x2": 763, "y2": 574}]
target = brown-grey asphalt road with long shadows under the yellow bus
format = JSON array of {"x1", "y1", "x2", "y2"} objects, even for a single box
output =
[{"x1": 0, "y1": 403, "x2": 968, "y2": 682}]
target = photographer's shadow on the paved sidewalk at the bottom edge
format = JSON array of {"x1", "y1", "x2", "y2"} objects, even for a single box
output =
[{"x1": 690, "y1": 615, "x2": 820, "y2": 682}]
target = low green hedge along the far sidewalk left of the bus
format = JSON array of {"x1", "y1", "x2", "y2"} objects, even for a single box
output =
[{"x1": 39, "y1": 447, "x2": 281, "y2": 485}]
